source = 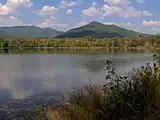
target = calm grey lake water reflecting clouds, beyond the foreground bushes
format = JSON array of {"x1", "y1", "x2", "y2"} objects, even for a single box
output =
[{"x1": 0, "y1": 53, "x2": 153, "y2": 110}]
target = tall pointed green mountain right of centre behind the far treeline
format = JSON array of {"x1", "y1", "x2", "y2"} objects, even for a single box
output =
[{"x1": 56, "y1": 21, "x2": 145, "y2": 38}]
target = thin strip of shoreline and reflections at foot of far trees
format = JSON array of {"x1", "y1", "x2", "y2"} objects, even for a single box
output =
[{"x1": 0, "y1": 47, "x2": 160, "y2": 54}]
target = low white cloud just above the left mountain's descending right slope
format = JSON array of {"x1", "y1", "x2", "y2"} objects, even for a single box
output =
[{"x1": 37, "y1": 16, "x2": 68, "y2": 29}]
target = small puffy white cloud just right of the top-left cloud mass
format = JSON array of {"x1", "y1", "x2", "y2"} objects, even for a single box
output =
[{"x1": 38, "y1": 5, "x2": 57, "y2": 16}]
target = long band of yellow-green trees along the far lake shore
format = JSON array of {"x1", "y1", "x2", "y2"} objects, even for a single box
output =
[{"x1": 0, "y1": 35, "x2": 160, "y2": 51}]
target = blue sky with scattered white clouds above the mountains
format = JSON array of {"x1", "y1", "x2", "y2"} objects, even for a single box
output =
[{"x1": 0, "y1": 0, "x2": 160, "y2": 34}]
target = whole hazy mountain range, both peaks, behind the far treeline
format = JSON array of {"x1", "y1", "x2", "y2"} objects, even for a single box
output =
[{"x1": 0, "y1": 21, "x2": 150, "y2": 38}]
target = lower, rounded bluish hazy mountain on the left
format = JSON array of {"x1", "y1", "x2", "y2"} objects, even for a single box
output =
[{"x1": 0, "y1": 26, "x2": 63, "y2": 38}]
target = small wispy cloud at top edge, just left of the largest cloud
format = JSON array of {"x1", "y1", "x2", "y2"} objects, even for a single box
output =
[{"x1": 60, "y1": 0, "x2": 83, "y2": 8}]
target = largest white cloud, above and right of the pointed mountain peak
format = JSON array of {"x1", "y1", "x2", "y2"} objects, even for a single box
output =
[{"x1": 82, "y1": 0, "x2": 152, "y2": 17}]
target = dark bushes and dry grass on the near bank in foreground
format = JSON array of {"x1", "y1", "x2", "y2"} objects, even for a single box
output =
[{"x1": 3, "y1": 55, "x2": 160, "y2": 120}]
